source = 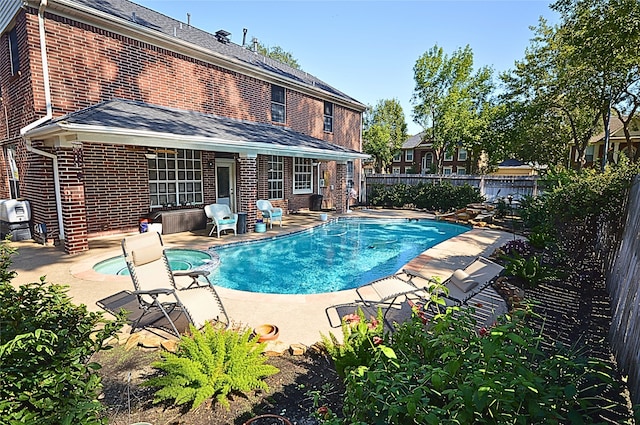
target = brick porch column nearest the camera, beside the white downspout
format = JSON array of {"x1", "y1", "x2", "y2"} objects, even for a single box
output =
[{"x1": 56, "y1": 147, "x2": 89, "y2": 254}]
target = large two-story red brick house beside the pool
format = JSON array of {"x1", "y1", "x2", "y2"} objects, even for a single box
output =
[{"x1": 0, "y1": 0, "x2": 367, "y2": 253}]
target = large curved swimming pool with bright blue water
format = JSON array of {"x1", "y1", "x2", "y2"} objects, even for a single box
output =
[{"x1": 209, "y1": 219, "x2": 469, "y2": 294}]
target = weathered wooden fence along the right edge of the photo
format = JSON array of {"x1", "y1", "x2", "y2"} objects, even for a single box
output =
[{"x1": 606, "y1": 176, "x2": 640, "y2": 404}]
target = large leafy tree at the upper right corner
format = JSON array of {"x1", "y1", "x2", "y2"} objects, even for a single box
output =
[{"x1": 502, "y1": 0, "x2": 640, "y2": 168}]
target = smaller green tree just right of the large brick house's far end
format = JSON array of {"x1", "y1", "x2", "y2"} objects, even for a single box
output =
[{"x1": 362, "y1": 99, "x2": 407, "y2": 173}]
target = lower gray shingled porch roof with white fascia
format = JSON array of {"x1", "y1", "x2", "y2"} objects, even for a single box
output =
[{"x1": 25, "y1": 99, "x2": 369, "y2": 161}]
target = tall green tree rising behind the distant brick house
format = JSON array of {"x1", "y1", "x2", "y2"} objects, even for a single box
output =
[{"x1": 412, "y1": 45, "x2": 494, "y2": 173}]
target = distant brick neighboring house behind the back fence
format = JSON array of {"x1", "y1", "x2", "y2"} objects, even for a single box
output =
[{"x1": 396, "y1": 132, "x2": 470, "y2": 175}]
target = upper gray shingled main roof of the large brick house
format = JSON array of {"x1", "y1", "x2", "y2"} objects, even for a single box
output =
[{"x1": 43, "y1": 0, "x2": 366, "y2": 111}]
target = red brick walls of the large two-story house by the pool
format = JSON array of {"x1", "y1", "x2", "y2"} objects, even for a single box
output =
[{"x1": 0, "y1": 8, "x2": 360, "y2": 250}]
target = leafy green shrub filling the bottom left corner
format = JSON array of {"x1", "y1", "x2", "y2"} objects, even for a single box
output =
[{"x1": 0, "y1": 242, "x2": 123, "y2": 425}]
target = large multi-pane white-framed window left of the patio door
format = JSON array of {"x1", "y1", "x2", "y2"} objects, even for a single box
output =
[{"x1": 147, "y1": 149, "x2": 203, "y2": 207}]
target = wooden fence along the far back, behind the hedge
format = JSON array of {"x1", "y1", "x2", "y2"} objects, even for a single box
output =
[{"x1": 365, "y1": 174, "x2": 541, "y2": 202}]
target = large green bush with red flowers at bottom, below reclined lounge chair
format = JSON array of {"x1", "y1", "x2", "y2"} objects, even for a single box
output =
[{"x1": 326, "y1": 308, "x2": 613, "y2": 424}]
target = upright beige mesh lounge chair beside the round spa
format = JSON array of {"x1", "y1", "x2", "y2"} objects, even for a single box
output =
[{"x1": 122, "y1": 232, "x2": 229, "y2": 337}]
